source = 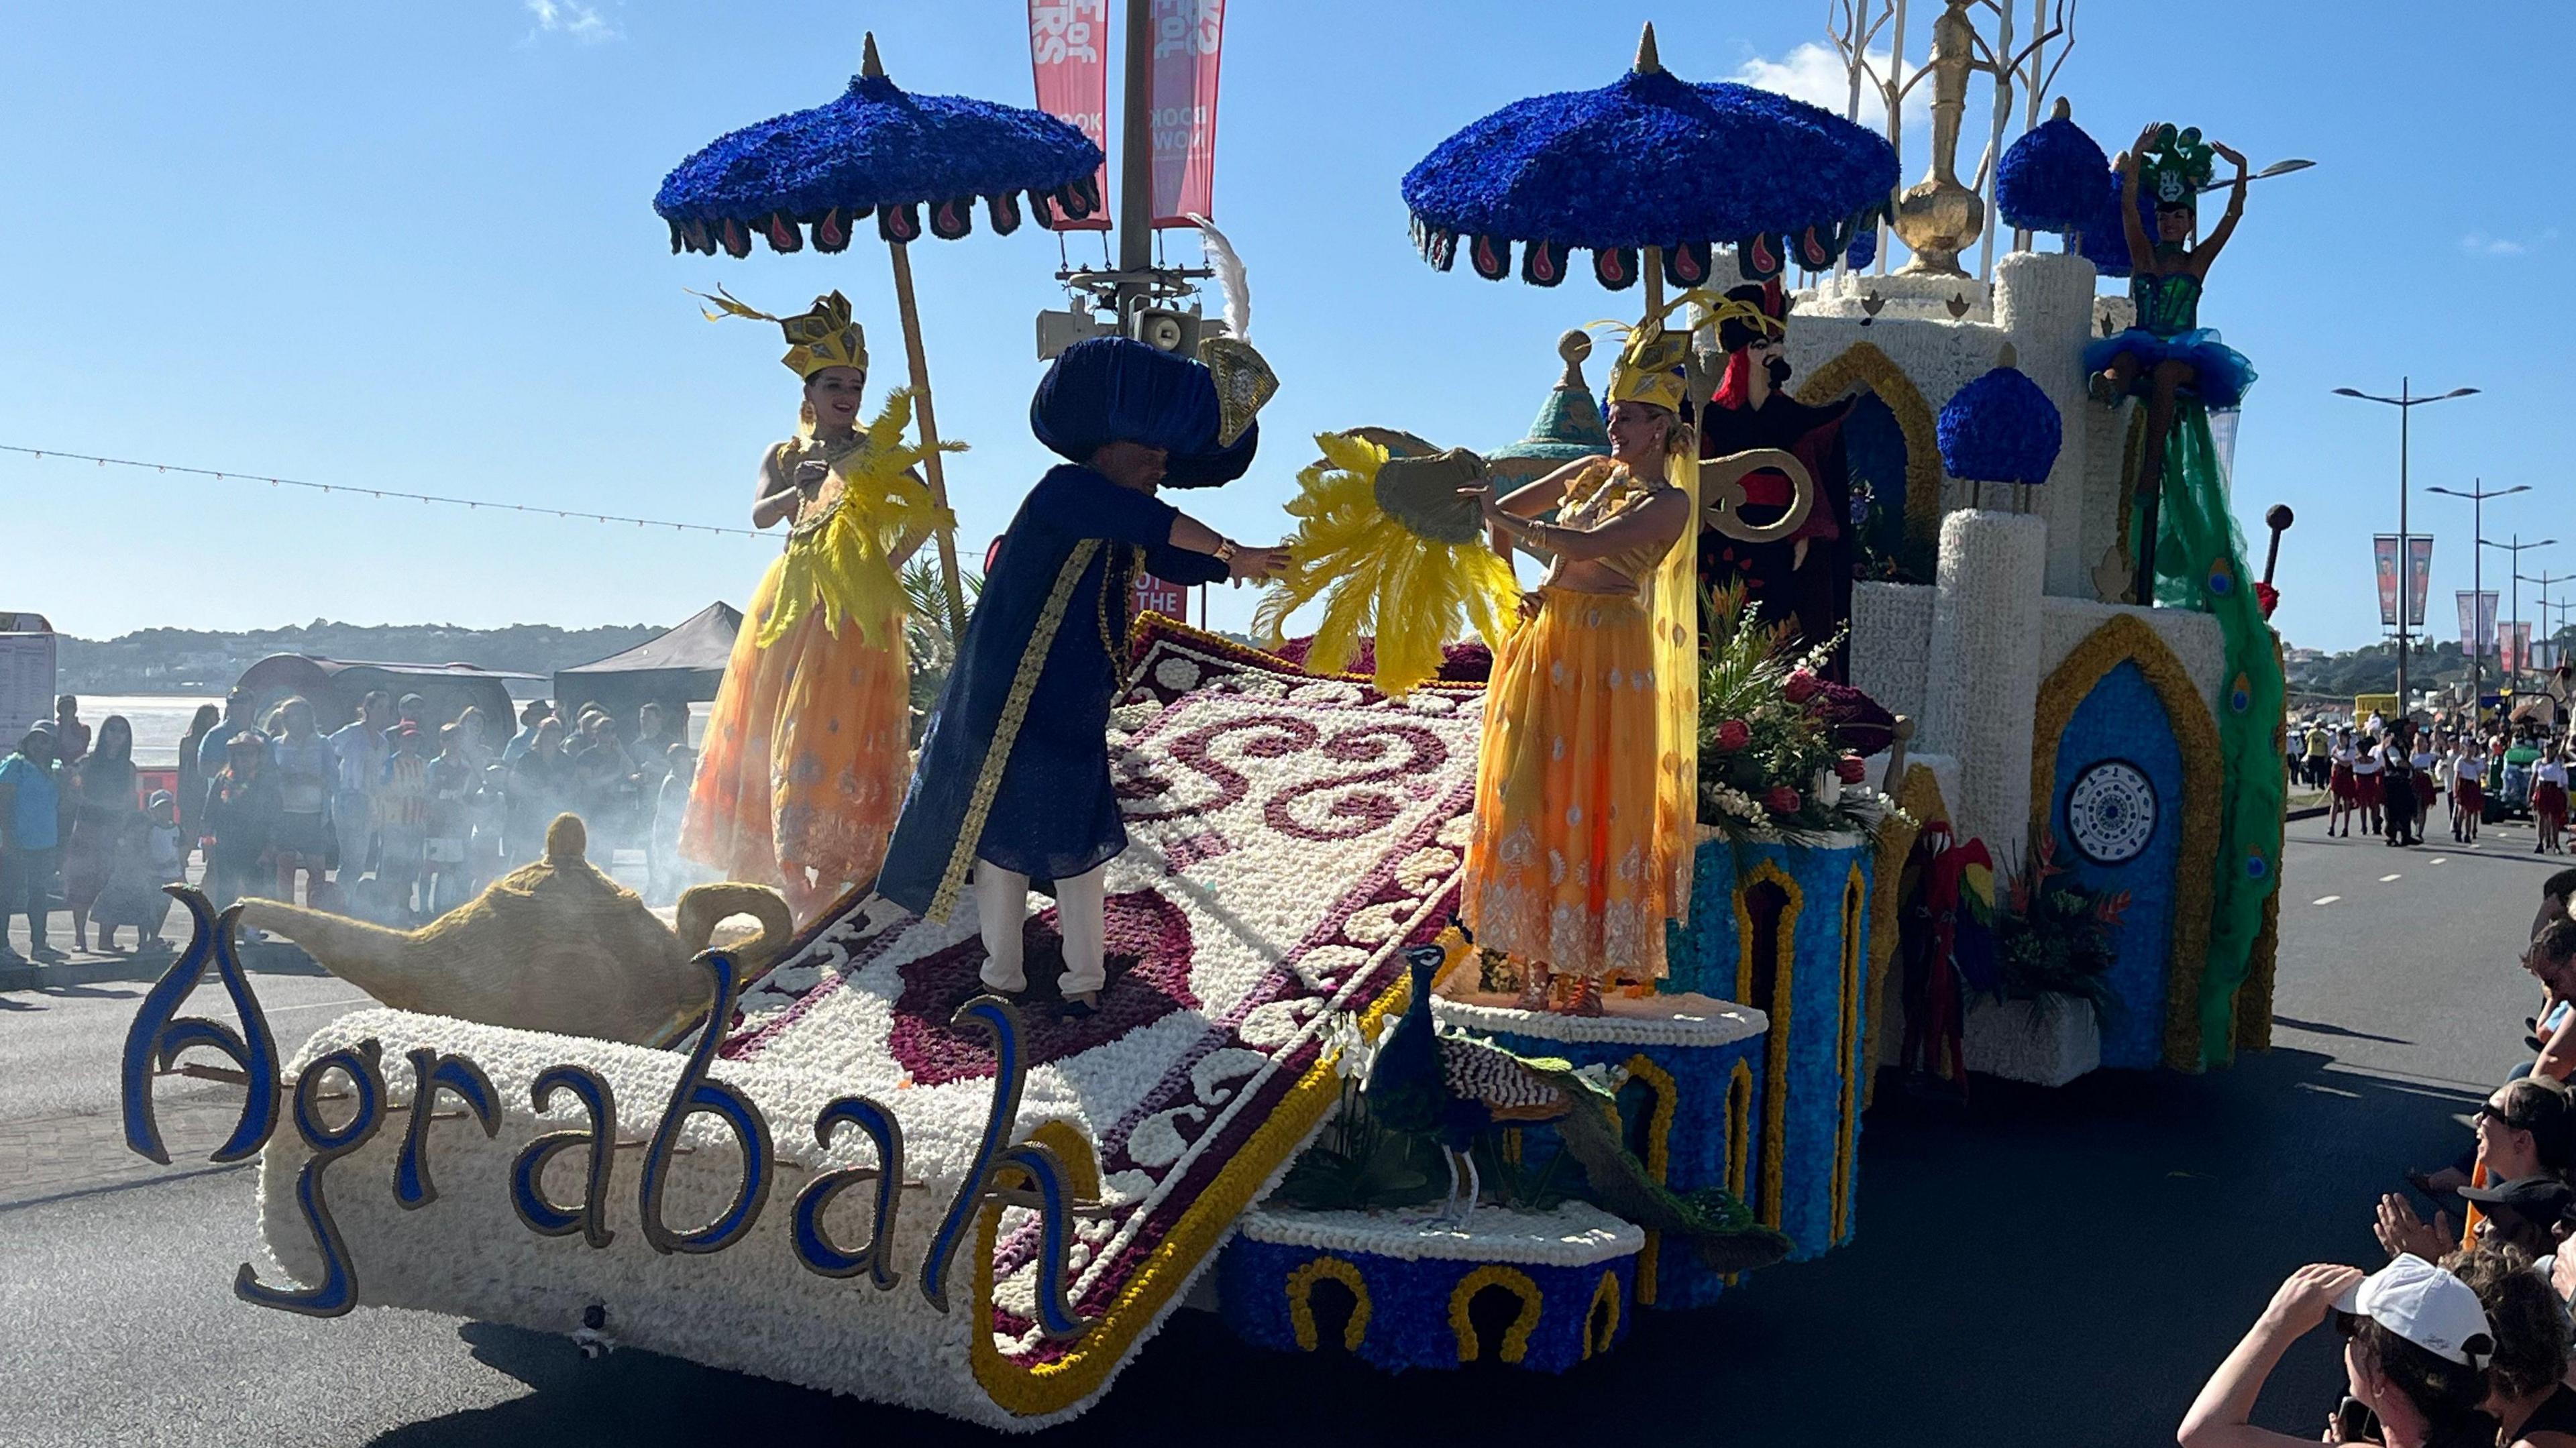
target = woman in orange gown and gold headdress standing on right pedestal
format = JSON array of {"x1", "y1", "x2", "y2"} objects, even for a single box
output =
[{"x1": 1460, "y1": 301, "x2": 1700, "y2": 1015}]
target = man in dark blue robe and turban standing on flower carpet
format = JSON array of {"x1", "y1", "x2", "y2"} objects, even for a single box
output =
[{"x1": 876, "y1": 337, "x2": 1285, "y2": 1015}]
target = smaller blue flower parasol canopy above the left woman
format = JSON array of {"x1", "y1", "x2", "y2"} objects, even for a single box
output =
[{"x1": 652, "y1": 36, "x2": 1100, "y2": 258}]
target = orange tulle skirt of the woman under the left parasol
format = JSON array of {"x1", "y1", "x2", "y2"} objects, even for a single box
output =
[{"x1": 680, "y1": 557, "x2": 912, "y2": 889}]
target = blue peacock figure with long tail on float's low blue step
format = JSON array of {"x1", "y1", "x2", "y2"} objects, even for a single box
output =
[{"x1": 1362, "y1": 946, "x2": 1790, "y2": 1273}]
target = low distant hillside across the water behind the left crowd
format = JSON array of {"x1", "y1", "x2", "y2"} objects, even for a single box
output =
[{"x1": 56, "y1": 618, "x2": 667, "y2": 693}]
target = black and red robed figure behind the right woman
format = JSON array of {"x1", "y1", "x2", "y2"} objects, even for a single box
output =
[{"x1": 1700, "y1": 281, "x2": 1852, "y2": 683}]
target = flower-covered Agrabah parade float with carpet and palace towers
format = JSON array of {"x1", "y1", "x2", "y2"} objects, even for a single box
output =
[{"x1": 123, "y1": 5, "x2": 2279, "y2": 1430}]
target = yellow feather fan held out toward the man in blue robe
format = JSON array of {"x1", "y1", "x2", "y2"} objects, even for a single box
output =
[{"x1": 1252, "y1": 433, "x2": 1520, "y2": 698}]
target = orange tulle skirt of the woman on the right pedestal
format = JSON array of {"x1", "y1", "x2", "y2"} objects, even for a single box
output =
[{"x1": 1460, "y1": 588, "x2": 1690, "y2": 982}]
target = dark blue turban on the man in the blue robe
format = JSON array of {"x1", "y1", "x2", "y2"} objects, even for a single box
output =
[{"x1": 1028, "y1": 337, "x2": 1263, "y2": 487}]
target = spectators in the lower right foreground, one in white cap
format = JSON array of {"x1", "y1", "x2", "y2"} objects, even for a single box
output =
[{"x1": 2180, "y1": 869, "x2": 2576, "y2": 1448}]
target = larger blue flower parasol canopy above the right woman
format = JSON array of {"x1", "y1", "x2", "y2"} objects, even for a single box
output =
[{"x1": 1404, "y1": 25, "x2": 1896, "y2": 288}]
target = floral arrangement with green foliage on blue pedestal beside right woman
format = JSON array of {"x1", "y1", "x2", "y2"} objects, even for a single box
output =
[{"x1": 1700, "y1": 585, "x2": 1898, "y2": 845}]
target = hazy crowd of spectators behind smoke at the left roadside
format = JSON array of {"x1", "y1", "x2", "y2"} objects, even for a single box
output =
[{"x1": 0, "y1": 691, "x2": 698, "y2": 964}]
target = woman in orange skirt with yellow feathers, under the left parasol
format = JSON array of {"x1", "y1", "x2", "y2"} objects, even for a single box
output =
[{"x1": 680, "y1": 291, "x2": 943, "y2": 922}]
